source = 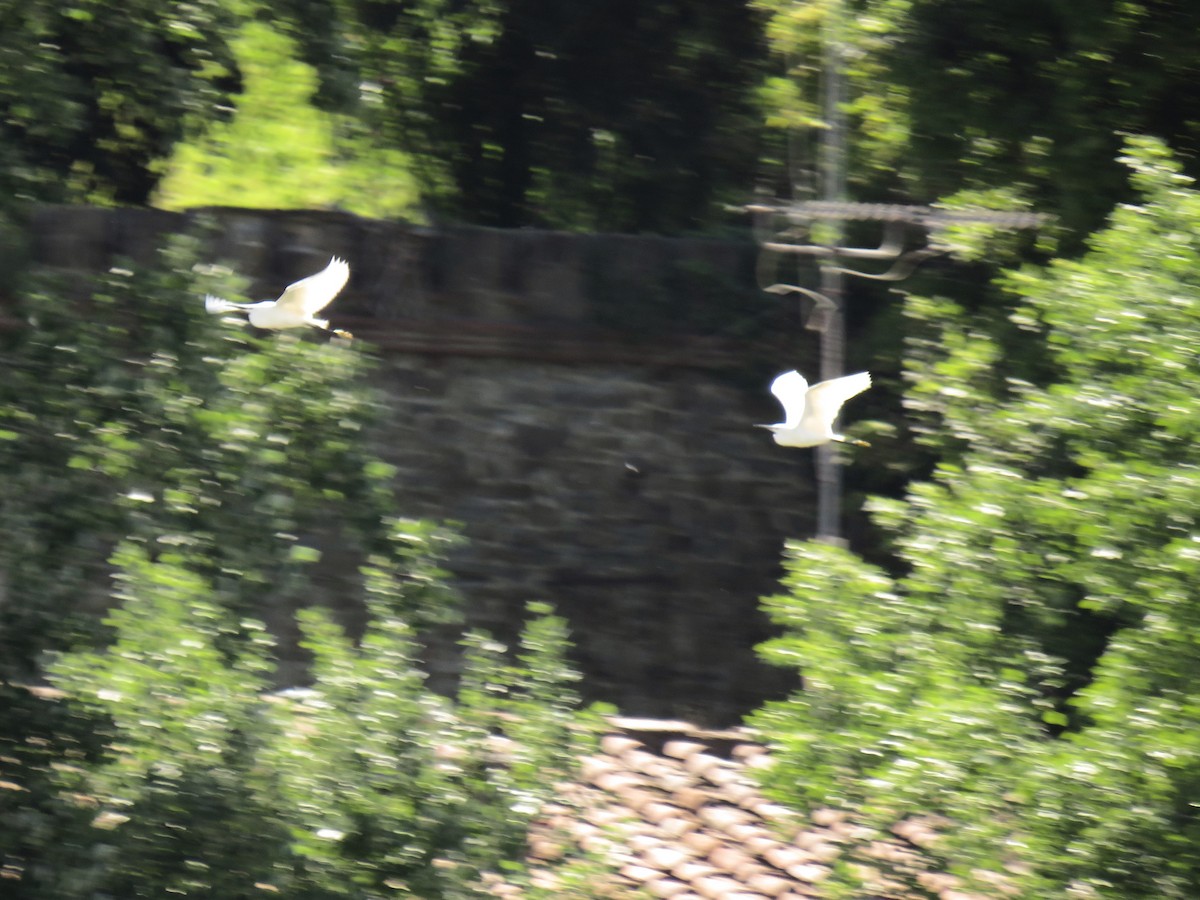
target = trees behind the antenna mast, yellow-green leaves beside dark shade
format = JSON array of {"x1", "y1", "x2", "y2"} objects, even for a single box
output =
[{"x1": 754, "y1": 0, "x2": 1200, "y2": 241}]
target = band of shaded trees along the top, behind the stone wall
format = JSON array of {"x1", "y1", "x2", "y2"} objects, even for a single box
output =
[{"x1": 11, "y1": 0, "x2": 1200, "y2": 239}]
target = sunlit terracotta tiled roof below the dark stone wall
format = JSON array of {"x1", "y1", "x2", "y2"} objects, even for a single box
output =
[{"x1": 491, "y1": 718, "x2": 1003, "y2": 900}]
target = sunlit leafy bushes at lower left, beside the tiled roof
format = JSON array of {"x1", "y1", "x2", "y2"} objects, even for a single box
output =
[{"x1": 32, "y1": 550, "x2": 588, "y2": 898}]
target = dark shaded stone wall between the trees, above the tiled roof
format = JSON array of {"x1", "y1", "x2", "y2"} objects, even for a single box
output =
[{"x1": 31, "y1": 208, "x2": 815, "y2": 724}]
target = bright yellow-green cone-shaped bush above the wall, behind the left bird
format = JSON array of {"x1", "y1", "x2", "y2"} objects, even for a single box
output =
[{"x1": 155, "y1": 22, "x2": 416, "y2": 217}]
